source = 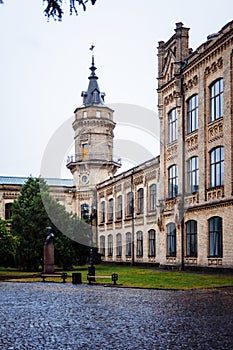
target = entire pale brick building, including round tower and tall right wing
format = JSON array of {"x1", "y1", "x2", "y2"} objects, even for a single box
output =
[{"x1": 0, "y1": 22, "x2": 233, "y2": 268}]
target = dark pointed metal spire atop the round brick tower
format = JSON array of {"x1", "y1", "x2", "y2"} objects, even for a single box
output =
[{"x1": 81, "y1": 44, "x2": 105, "y2": 106}]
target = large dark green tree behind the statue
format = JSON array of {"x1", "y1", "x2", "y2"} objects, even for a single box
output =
[{"x1": 12, "y1": 177, "x2": 89, "y2": 271}]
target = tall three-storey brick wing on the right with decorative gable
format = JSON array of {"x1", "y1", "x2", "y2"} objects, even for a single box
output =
[{"x1": 158, "y1": 22, "x2": 233, "y2": 267}]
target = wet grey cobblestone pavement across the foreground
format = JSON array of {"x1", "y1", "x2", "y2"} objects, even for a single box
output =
[{"x1": 0, "y1": 282, "x2": 233, "y2": 350}]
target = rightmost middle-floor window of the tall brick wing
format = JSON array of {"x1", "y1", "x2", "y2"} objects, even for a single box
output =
[{"x1": 210, "y1": 147, "x2": 224, "y2": 187}]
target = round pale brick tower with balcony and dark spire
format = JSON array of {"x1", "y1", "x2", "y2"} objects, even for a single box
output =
[{"x1": 67, "y1": 50, "x2": 120, "y2": 217}]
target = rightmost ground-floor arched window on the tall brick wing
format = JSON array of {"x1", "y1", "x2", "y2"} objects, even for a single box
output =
[{"x1": 208, "y1": 216, "x2": 222, "y2": 258}]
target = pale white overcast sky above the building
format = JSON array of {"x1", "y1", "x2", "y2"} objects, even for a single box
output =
[{"x1": 0, "y1": 0, "x2": 233, "y2": 177}]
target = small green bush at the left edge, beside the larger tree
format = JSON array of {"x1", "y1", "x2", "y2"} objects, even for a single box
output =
[{"x1": 0, "y1": 219, "x2": 17, "y2": 267}]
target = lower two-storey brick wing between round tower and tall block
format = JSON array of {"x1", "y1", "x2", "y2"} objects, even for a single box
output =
[{"x1": 97, "y1": 157, "x2": 160, "y2": 264}]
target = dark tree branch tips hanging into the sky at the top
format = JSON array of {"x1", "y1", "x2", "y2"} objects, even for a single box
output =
[{"x1": 0, "y1": 0, "x2": 96, "y2": 21}]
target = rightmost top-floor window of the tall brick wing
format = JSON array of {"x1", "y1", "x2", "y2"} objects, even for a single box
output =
[{"x1": 210, "y1": 79, "x2": 223, "y2": 122}]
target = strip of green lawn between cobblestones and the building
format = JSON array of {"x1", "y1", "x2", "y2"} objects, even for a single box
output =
[{"x1": 0, "y1": 265, "x2": 233, "y2": 290}]
